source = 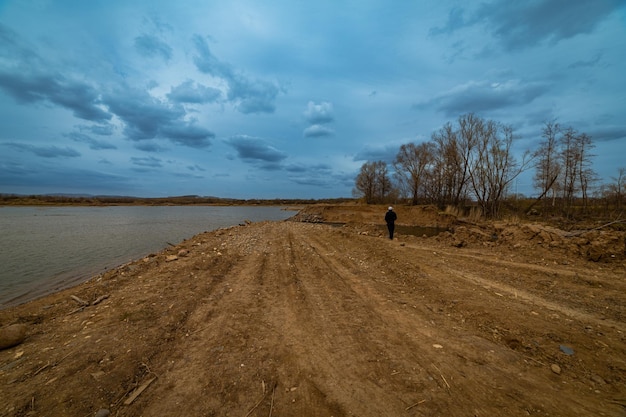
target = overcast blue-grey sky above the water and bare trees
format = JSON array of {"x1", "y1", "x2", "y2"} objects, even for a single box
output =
[{"x1": 0, "y1": 0, "x2": 626, "y2": 198}]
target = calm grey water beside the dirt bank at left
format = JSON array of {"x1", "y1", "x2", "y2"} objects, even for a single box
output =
[{"x1": 0, "y1": 206, "x2": 295, "y2": 308}]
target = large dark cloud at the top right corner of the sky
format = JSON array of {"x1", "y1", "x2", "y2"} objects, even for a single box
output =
[{"x1": 430, "y1": 0, "x2": 623, "y2": 50}]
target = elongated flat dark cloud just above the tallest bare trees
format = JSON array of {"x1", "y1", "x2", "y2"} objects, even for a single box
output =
[{"x1": 413, "y1": 81, "x2": 549, "y2": 117}]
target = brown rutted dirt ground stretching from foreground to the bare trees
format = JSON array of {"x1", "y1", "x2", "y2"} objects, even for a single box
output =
[{"x1": 0, "y1": 206, "x2": 626, "y2": 417}]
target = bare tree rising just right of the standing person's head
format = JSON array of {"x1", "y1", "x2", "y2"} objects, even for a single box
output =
[{"x1": 393, "y1": 142, "x2": 434, "y2": 205}]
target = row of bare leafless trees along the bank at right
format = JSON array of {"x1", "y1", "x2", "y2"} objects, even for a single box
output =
[{"x1": 353, "y1": 113, "x2": 626, "y2": 218}]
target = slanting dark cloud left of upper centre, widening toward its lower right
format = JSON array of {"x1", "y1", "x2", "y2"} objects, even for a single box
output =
[{"x1": 193, "y1": 35, "x2": 280, "y2": 114}]
